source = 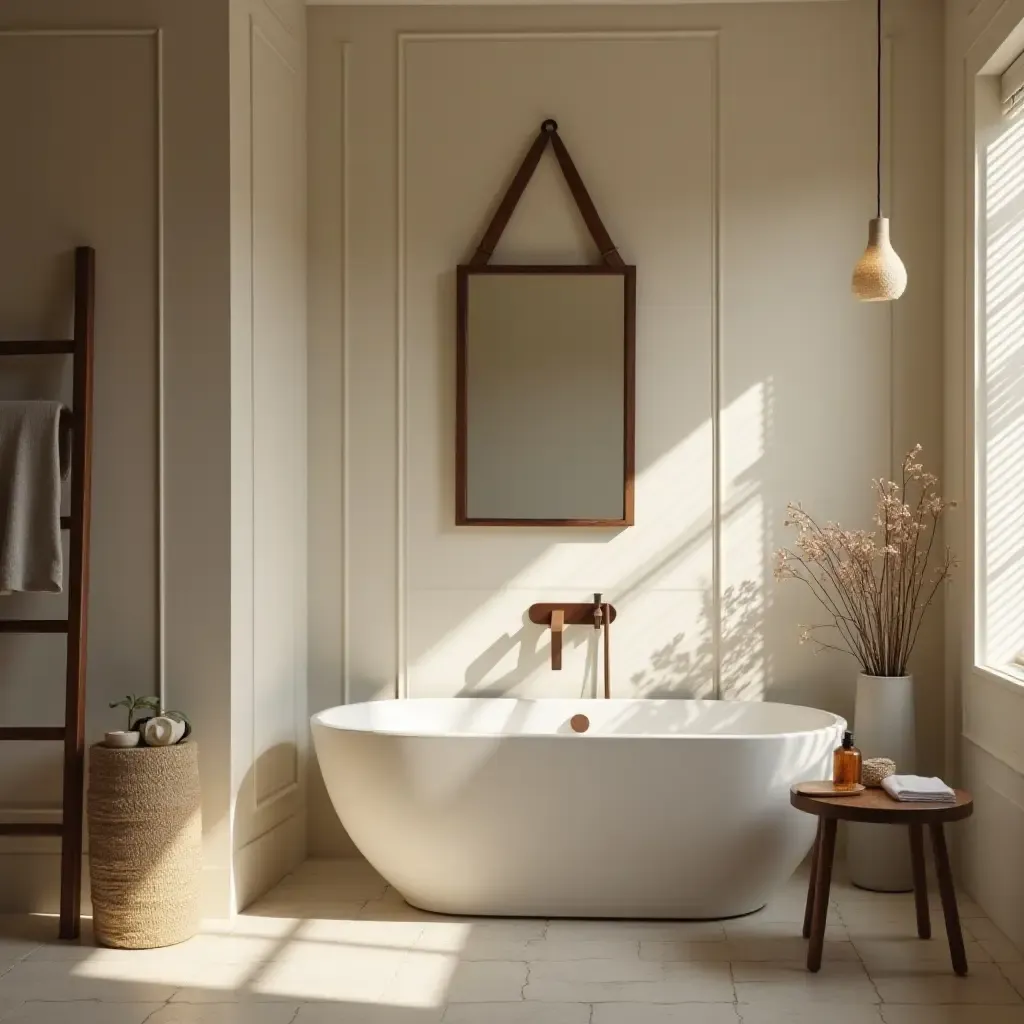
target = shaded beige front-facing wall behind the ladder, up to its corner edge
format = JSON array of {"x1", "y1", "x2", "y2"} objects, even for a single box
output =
[{"x1": 0, "y1": 0, "x2": 230, "y2": 906}]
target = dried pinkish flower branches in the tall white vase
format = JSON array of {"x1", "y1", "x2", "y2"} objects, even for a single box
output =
[{"x1": 775, "y1": 444, "x2": 956, "y2": 676}]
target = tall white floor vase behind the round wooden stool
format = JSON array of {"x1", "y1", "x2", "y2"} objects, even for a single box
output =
[{"x1": 847, "y1": 674, "x2": 918, "y2": 893}]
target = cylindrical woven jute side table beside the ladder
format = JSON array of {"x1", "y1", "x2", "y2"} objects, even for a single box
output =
[{"x1": 88, "y1": 742, "x2": 203, "y2": 949}]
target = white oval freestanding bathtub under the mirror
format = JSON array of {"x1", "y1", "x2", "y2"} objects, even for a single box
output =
[{"x1": 312, "y1": 697, "x2": 846, "y2": 919}]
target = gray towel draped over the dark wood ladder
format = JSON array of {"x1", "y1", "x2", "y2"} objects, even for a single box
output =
[{"x1": 0, "y1": 401, "x2": 63, "y2": 593}]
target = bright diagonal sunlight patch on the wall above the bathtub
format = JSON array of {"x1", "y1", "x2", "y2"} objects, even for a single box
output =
[{"x1": 438, "y1": 372, "x2": 806, "y2": 702}]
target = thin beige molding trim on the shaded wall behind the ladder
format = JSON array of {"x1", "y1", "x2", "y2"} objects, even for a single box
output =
[{"x1": 0, "y1": 28, "x2": 167, "y2": 823}]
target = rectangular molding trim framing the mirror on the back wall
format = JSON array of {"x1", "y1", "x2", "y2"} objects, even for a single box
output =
[{"x1": 391, "y1": 29, "x2": 720, "y2": 703}]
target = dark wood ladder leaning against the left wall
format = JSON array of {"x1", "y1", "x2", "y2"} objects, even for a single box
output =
[{"x1": 0, "y1": 246, "x2": 96, "y2": 939}]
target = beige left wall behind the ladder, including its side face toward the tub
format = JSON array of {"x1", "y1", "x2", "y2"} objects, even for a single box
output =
[{"x1": 0, "y1": 0, "x2": 306, "y2": 914}]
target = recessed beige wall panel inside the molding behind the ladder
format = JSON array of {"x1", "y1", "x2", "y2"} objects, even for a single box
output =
[{"x1": 0, "y1": 30, "x2": 159, "y2": 847}]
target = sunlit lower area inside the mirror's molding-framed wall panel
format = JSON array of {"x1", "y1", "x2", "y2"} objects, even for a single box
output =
[{"x1": 410, "y1": 422, "x2": 712, "y2": 696}]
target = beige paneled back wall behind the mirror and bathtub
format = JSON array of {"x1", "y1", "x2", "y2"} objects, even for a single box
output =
[{"x1": 308, "y1": 0, "x2": 943, "y2": 852}]
